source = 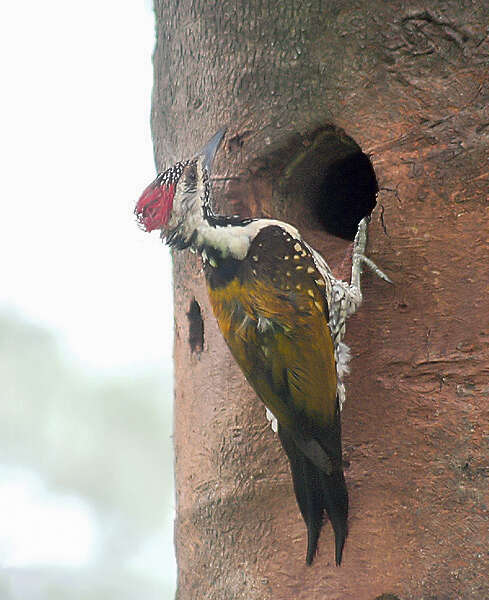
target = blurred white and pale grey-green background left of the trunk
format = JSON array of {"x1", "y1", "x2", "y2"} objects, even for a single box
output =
[{"x1": 0, "y1": 0, "x2": 175, "y2": 600}]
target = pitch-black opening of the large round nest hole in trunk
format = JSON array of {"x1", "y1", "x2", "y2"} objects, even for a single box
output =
[{"x1": 316, "y1": 150, "x2": 379, "y2": 240}]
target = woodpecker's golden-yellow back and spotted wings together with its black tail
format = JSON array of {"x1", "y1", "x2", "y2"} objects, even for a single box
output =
[{"x1": 206, "y1": 226, "x2": 348, "y2": 564}]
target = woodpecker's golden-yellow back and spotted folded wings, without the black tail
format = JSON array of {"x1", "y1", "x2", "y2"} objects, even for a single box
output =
[{"x1": 207, "y1": 226, "x2": 336, "y2": 433}]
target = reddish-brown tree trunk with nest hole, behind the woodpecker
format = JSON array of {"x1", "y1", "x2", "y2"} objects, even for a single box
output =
[{"x1": 153, "y1": 0, "x2": 489, "y2": 600}]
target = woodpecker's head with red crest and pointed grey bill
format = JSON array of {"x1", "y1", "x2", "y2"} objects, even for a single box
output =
[{"x1": 134, "y1": 129, "x2": 225, "y2": 244}]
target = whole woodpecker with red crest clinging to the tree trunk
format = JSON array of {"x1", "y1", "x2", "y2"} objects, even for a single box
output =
[{"x1": 135, "y1": 130, "x2": 389, "y2": 565}]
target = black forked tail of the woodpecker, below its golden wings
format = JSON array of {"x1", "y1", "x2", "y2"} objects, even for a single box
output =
[{"x1": 279, "y1": 426, "x2": 348, "y2": 565}]
